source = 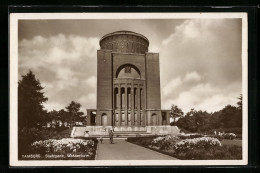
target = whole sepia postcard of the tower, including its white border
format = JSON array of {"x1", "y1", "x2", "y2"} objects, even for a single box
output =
[{"x1": 10, "y1": 13, "x2": 248, "y2": 166}]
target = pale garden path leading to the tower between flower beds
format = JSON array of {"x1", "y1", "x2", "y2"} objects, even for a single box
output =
[{"x1": 96, "y1": 139, "x2": 176, "y2": 160}]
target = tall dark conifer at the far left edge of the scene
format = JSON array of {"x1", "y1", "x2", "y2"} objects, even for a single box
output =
[{"x1": 18, "y1": 71, "x2": 48, "y2": 129}]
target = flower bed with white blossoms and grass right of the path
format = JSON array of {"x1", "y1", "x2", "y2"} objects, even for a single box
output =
[{"x1": 127, "y1": 134, "x2": 242, "y2": 160}]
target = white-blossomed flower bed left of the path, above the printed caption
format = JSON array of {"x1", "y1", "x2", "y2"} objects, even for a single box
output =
[{"x1": 22, "y1": 138, "x2": 97, "y2": 160}]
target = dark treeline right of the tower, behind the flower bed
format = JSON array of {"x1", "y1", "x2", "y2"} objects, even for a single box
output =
[{"x1": 171, "y1": 95, "x2": 242, "y2": 134}]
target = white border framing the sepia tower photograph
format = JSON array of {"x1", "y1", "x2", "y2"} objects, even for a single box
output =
[{"x1": 9, "y1": 13, "x2": 248, "y2": 166}]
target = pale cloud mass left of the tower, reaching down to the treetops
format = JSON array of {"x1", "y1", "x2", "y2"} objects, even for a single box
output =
[{"x1": 18, "y1": 34, "x2": 99, "y2": 109}]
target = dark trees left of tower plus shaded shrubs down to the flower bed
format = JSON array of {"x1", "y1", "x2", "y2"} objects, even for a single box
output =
[{"x1": 18, "y1": 71, "x2": 86, "y2": 156}]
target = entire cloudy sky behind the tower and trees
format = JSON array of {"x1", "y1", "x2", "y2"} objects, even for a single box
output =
[{"x1": 18, "y1": 19, "x2": 242, "y2": 112}]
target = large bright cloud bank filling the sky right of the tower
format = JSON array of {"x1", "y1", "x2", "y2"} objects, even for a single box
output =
[{"x1": 160, "y1": 19, "x2": 242, "y2": 112}]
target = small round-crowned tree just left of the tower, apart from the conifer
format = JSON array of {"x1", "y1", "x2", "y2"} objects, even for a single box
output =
[{"x1": 66, "y1": 101, "x2": 84, "y2": 127}]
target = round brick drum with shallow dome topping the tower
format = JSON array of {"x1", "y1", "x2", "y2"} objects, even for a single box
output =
[{"x1": 99, "y1": 31, "x2": 149, "y2": 54}]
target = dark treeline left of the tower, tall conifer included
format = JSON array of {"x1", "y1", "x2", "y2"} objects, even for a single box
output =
[{"x1": 18, "y1": 71, "x2": 86, "y2": 130}]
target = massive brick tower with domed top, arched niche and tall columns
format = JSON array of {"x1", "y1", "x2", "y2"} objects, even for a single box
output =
[{"x1": 87, "y1": 31, "x2": 170, "y2": 126}]
